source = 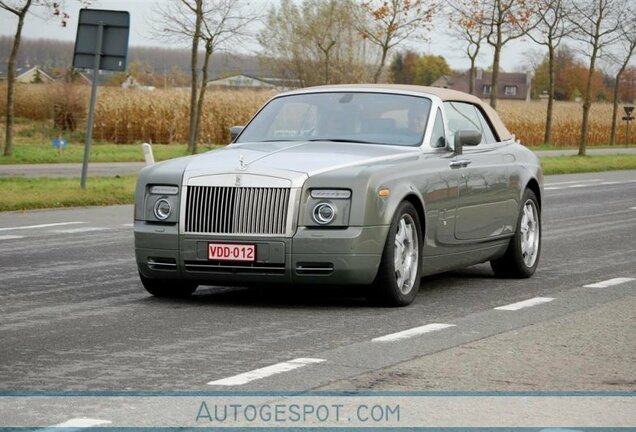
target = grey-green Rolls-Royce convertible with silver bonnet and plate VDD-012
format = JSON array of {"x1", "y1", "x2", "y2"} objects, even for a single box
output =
[{"x1": 135, "y1": 85, "x2": 543, "y2": 305}]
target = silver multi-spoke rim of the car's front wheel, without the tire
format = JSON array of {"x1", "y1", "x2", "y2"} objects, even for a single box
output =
[{"x1": 393, "y1": 213, "x2": 419, "y2": 294}]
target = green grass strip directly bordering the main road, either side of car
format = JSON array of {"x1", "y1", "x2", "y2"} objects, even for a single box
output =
[{"x1": 0, "y1": 154, "x2": 636, "y2": 211}]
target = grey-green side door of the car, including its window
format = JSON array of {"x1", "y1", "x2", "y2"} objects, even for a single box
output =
[{"x1": 444, "y1": 102, "x2": 513, "y2": 241}]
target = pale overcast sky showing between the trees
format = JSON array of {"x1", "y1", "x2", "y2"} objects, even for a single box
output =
[{"x1": 0, "y1": 0, "x2": 540, "y2": 71}]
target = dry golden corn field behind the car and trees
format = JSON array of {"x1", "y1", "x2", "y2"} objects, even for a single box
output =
[{"x1": 0, "y1": 84, "x2": 636, "y2": 146}]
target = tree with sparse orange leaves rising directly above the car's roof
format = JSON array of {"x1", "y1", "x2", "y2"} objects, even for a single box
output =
[{"x1": 359, "y1": 0, "x2": 437, "y2": 83}]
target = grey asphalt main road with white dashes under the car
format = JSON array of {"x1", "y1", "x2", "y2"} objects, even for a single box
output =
[{"x1": 0, "y1": 171, "x2": 636, "y2": 391}]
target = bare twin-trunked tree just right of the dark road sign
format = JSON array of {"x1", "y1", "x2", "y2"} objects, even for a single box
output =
[{"x1": 156, "y1": 0, "x2": 258, "y2": 154}]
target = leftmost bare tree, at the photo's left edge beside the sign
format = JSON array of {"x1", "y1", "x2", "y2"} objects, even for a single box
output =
[{"x1": 0, "y1": 0, "x2": 79, "y2": 156}]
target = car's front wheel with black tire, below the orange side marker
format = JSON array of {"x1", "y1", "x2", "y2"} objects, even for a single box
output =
[{"x1": 373, "y1": 201, "x2": 422, "y2": 306}]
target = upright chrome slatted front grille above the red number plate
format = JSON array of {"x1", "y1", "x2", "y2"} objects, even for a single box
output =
[{"x1": 185, "y1": 186, "x2": 290, "y2": 235}]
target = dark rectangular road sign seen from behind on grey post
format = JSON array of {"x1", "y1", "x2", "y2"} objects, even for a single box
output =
[{"x1": 73, "y1": 9, "x2": 130, "y2": 189}]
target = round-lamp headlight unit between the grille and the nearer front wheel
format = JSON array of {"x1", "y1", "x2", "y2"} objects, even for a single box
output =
[{"x1": 303, "y1": 189, "x2": 351, "y2": 228}]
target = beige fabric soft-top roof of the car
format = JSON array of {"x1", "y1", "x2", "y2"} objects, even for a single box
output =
[{"x1": 291, "y1": 84, "x2": 512, "y2": 141}]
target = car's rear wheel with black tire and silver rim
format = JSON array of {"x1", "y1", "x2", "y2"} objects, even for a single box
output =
[{"x1": 490, "y1": 189, "x2": 541, "y2": 279}]
